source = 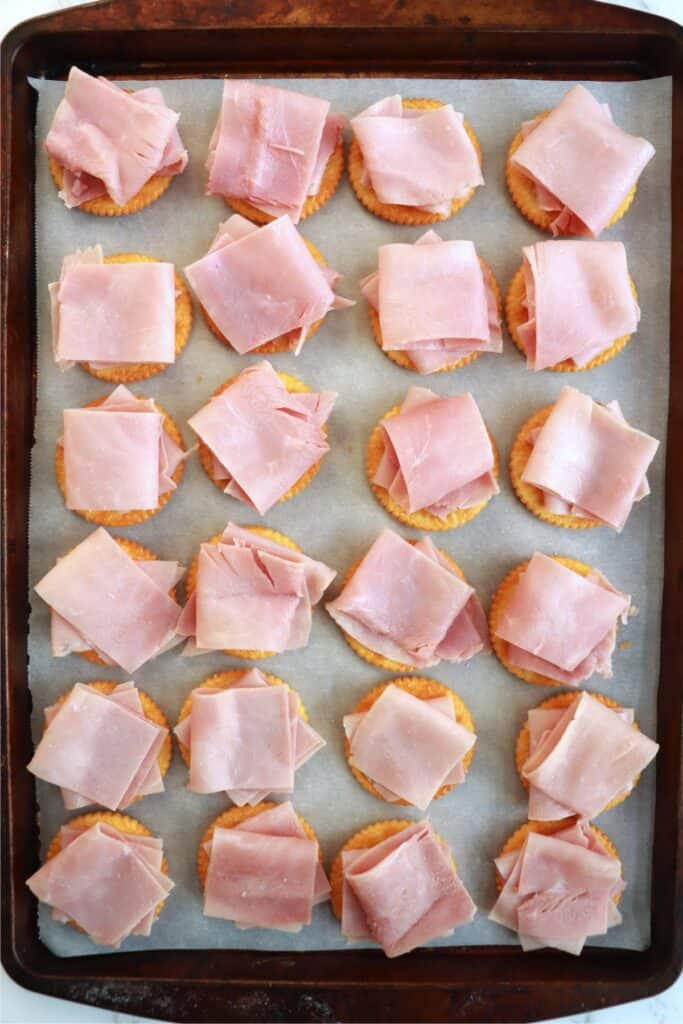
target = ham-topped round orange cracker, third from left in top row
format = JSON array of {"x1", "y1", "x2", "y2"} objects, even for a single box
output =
[{"x1": 348, "y1": 95, "x2": 484, "y2": 224}]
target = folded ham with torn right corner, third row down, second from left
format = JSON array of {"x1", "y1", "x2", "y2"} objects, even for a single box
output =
[{"x1": 188, "y1": 361, "x2": 337, "y2": 515}]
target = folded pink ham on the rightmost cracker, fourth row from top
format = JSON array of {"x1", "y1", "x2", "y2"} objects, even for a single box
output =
[{"x1": 496, "y1": 552, "x2": 631, "y2": 686}]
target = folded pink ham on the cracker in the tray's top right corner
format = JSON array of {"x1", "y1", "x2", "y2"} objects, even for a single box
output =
[{"x1": 510, "y1": 85, "x2": 654, "y2": 238}]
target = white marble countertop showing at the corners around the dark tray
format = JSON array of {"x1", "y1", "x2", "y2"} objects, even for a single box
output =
[{"x1": 0, "y1": 0, "x2": 683, "y2": 1024}]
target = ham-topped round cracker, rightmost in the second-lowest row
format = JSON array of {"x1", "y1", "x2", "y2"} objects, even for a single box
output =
[{"x1": 515, "y1": 690, "x2": 659, "y2": 821}]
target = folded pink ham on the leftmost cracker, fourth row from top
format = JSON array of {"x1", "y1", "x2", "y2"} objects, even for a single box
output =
[{"x1": 35, "y1": 526, "x2": 182, "y2": 673}]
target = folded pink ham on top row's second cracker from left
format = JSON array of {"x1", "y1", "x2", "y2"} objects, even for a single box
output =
[{"x1": 206, "y1": 79, "x2": 344, "y2": 224}]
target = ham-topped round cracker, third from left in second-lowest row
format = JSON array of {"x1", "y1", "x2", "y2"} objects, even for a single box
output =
[{"x1": 343, "y1": 676, "x2": 476, "y2": 811}]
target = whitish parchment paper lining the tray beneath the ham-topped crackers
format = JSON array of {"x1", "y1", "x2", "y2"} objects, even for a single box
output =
[{"x1": 29, "y1": 78, "x2": 672, "y2": 956}]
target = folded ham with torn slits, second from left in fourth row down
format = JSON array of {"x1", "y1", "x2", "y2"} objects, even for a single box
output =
[{"x1": 178, "y1": 523, "x2": 336, "y2": 653}]
